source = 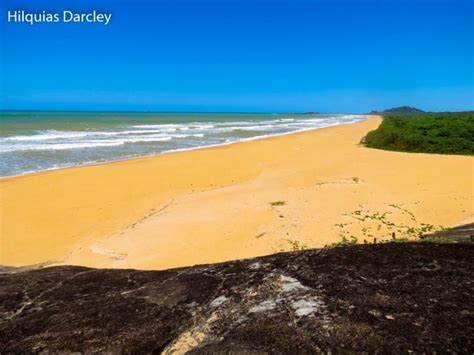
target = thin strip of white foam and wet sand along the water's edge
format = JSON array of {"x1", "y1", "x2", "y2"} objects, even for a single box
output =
[{"x1": 0, "y1": 115, "x2": 366, "y2": 181}]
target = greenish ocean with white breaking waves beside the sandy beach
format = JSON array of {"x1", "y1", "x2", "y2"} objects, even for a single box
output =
[{"x1": 0, "y1": 111, "x2": 366, "y2": 177}]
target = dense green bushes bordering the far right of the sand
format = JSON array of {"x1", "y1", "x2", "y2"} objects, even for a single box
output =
[{"x1": 366, "y1": 111, "x2": 474, "y2": 155}]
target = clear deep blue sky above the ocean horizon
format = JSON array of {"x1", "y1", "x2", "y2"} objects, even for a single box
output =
[{"x1": 0, "y1": 0, "x2": 474, "y2": 112}]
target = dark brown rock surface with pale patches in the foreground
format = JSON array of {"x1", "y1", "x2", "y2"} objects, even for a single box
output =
[{"x1": 0, "y1": 243, "x2": 474, "y2": 354}]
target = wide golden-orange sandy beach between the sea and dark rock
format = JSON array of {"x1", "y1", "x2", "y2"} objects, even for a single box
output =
[{"x1": 0, "y1": 116, "x2": 474, "y2": 269}]
